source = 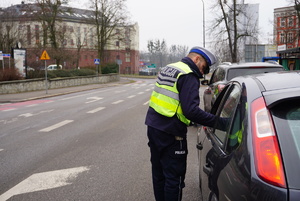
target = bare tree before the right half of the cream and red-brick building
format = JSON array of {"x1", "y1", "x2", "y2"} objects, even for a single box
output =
[{"x1": 91, "y1": 0, "x2": 128, "y2": 74}]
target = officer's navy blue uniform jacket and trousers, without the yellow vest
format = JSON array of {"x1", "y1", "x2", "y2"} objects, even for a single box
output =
[{"x1": 145, "y1": 47, "x2": 216, "y2": 201}]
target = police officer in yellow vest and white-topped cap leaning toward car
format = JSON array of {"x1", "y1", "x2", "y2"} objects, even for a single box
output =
[{"x1": 145, "y1": 47, "x2": 223, "y2": 201}]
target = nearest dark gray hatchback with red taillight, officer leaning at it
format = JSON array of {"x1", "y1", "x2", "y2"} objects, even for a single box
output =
[{"x1": 197, "y1": 71, "x2": 300, "y2": 201}]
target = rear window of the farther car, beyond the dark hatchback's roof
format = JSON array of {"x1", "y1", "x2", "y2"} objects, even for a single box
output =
[{"x1": 227, "y1": 67, "x2": 283, "y2": 81}]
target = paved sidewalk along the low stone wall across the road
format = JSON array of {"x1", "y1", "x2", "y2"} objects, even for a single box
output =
[{"x1": 0, "y1": 77, "x2": 132, "y2": 103}]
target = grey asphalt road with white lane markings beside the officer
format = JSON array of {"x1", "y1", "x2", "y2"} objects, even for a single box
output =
[{"x1": 0, "y1": 79, "x2": 204, "y2": 201}]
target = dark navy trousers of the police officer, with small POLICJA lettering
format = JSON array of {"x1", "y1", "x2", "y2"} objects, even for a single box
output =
[{"x1": 148, "y1": 126, "x2": 188, "y2": 201}]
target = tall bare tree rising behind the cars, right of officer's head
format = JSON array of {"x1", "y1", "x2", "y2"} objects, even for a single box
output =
[{"x1": 210, "y1": 0, "x2": 258, "y2": 62}]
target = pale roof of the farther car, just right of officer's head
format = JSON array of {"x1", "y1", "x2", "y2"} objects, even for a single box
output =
[{"x1": 218, "y1": 62, "x2": 283, "y2": 69}]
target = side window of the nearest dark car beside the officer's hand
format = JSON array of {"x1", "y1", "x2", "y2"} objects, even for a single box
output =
[{"x1": 214, "y1": 85, "x2": 241, "y2": 147}]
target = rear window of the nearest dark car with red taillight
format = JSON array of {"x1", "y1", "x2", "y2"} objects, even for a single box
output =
[{"x1": 271, "y1": 99, "x2": 300, "y2": 189}]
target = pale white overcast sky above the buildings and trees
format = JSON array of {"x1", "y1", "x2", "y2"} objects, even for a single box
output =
[{"x1": 0, "y1": 0, "x2": 290, "y2": 51}]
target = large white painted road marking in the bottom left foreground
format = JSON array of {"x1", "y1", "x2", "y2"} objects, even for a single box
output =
[{"x1": 0, "y1": 166, "x2": 90, "y2": 200}]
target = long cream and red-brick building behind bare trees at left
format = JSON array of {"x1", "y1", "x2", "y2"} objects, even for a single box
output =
[{"x1": 0, "y1": 3, "x2": 139, "y2": 74}]
